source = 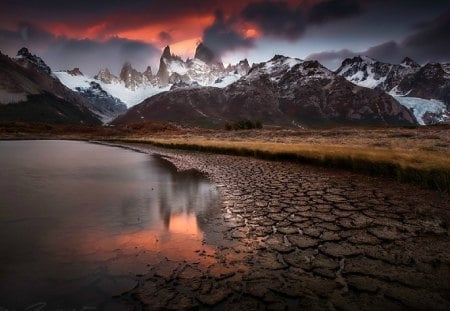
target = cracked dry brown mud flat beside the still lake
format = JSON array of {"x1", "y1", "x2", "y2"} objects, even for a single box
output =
[{"x1": 115, "y1": 144, "x2": 450, "y2": 310}]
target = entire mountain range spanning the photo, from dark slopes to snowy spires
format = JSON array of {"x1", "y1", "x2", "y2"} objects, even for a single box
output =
[{"x1": 0, "y1": 44, "x2": 450, "y2": 127}]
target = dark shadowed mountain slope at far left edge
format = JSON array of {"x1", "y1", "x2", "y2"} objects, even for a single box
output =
[{"x1": 0, "y1": 49, "x2": 101, "y2": 124}]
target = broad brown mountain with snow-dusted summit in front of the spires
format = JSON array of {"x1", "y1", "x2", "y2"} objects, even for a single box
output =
[{"x1": 113, "y1": 55, "x2": 416, "y2": 127}]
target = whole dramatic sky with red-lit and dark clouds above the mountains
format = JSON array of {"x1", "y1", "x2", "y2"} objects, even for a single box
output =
[{"x1": 0, "y1": 0, "x2": 450, "y2": 76}]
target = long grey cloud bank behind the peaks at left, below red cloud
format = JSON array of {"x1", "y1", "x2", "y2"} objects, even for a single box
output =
[{"x1": 0, "y1": 24, "x2": 161, "y2": 75}]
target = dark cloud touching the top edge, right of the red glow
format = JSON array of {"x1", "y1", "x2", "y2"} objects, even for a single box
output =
[{"x1": 241, "y1": 0, "x2": 362, "y2": 40}]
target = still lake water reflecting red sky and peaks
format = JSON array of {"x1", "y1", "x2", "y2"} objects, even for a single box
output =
[{"x1": 0, "y1": 141, "x2": 218, "y2": 310}]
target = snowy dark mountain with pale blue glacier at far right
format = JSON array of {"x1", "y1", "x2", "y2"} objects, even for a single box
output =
[{"x1": 336, "y1": 56, "x2": 450, "y2": 125}]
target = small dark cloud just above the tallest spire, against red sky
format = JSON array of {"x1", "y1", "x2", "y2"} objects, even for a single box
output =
[{"x1": 203, "y1": 11, "x2": 254, "y2": 55}]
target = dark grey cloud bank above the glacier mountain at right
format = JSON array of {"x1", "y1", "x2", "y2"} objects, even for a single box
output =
[{"x1": 307, "y1": 11, "x2": 450, "y2": 68}]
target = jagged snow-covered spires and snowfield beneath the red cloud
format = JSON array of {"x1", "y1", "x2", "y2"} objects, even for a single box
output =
[{"x1": 54, "y1": 43, "x2": 250, "y2": 107}]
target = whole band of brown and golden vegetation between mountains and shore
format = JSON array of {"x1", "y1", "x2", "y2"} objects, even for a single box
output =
[{"x1": 0, "y1": 122, "x2": 450, "y2": 192}]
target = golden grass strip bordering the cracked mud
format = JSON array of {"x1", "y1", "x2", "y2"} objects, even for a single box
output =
[{"x1": 111, "y1": 137, "x2": 450, "y2": 192}]
